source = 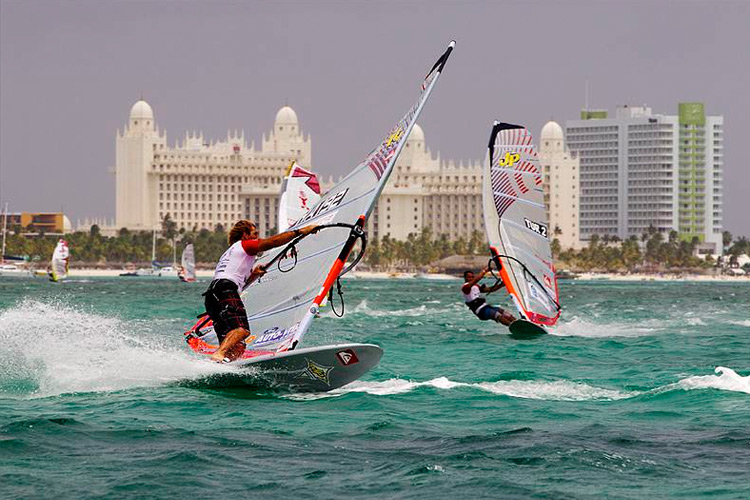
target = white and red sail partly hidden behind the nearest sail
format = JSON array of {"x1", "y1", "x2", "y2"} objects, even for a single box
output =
[{"x1": 278, "y1": 160, "x2": 320, "y2": 233}]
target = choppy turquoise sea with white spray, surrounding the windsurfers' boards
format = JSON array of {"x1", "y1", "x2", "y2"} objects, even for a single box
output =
[{"x1": 0, "y1": 279, "x2": 750, "y2": 499}]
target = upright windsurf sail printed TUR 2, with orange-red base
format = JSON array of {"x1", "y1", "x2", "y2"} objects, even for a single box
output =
[{"x1": 482, "y1": 122, "x2": 560, "y2": 326}]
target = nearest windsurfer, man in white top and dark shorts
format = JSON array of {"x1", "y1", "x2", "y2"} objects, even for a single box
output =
[{"x1": 203, "y1": 220, "x2": 317, "y2": 361}]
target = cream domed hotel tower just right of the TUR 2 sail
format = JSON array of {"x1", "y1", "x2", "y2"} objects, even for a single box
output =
[{"x1": 539, "y1": 121, "x2": 580, "y2": 249}]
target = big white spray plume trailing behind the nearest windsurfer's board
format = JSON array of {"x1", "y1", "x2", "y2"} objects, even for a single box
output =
[{"x1": 0, "y1": 300, "x2": 231, "y2": 396}]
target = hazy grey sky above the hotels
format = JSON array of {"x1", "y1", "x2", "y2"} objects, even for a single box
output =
[{"x1": 0, "y1": 0, "x2": 750, "y2": 235}]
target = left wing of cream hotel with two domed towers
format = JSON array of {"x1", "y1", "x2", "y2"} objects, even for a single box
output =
[{"x1": 115, "y1": 100, "x2": 311, "y2": 236}]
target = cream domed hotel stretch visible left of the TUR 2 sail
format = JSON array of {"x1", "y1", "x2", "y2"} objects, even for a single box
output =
[{"x1": 115, "y1": 100, "x2": 484, "y2": 240}]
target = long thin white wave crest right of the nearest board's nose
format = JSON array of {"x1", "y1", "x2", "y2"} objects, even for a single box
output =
[{"x1": 291, "y1": 377, "x2": 640, "y2": 401}]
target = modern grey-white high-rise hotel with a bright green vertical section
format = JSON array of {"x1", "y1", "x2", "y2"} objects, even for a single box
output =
[{"x1": 566, "y1": 102, "x2": 724, "y2": 252}]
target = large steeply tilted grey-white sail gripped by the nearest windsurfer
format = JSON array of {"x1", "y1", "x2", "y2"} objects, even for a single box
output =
[{"x1": 191, "y1": 42, "x2": 455, "y2": 352}]
